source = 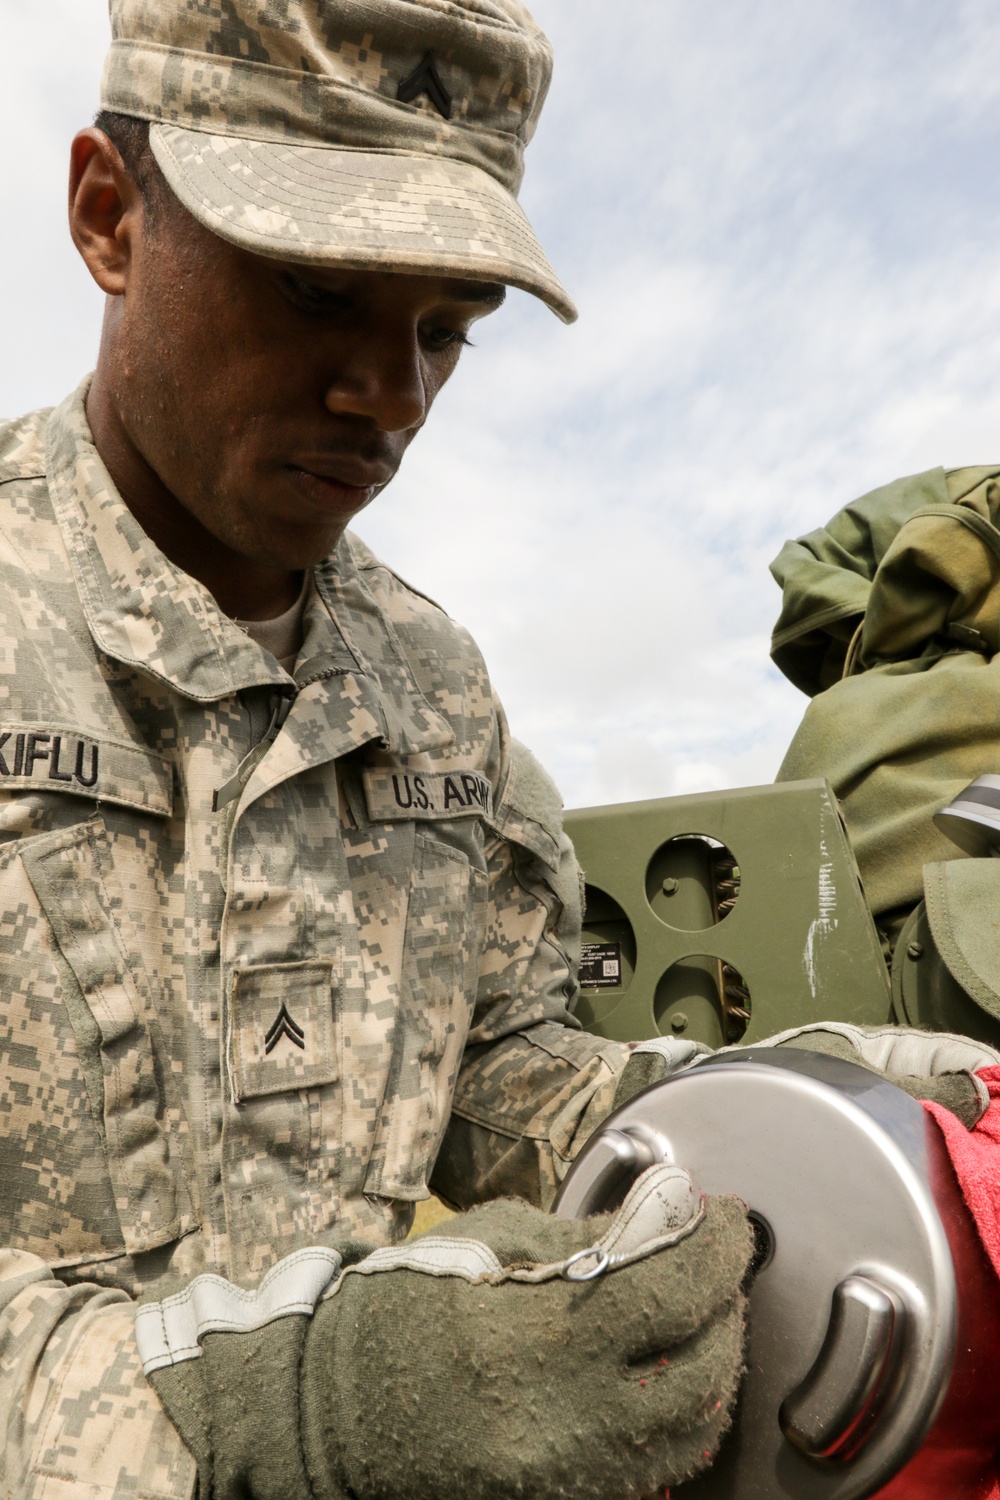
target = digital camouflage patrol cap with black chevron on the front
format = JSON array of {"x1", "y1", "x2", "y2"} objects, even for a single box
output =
[{"x1": 100, "y1": 0, "x2": 576, "y2": 323}]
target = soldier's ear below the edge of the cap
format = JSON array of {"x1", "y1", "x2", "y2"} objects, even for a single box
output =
[{"x1": 69, "y1": 128, "x2": 142, "y2": 297}]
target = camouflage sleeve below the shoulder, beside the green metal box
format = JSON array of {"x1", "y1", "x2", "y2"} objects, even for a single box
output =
[{"x1": 432, "y1": 716, "x2": 628, "y2": 1208}]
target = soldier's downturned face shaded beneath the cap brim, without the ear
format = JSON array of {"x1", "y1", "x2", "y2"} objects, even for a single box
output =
[{"x1": 71, "y1": 132, "x2": 502, "y2": 569}]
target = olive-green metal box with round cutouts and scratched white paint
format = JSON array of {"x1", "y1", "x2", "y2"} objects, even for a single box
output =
[{"x1": 565, "y1": 782, "x2": 892, "y2": 1047}]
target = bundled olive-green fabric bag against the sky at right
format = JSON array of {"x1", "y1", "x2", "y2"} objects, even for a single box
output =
[{"x1": 772, "y1": 468, "x2": 1000, "y2": 944}]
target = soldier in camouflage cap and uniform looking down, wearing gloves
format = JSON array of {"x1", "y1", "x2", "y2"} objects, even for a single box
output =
[{"x1": 0, "y1": 0, "x2": 750, "y2": 1500}]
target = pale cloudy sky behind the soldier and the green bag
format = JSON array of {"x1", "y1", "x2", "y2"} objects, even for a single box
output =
[{"x1": 0, "y1": 0, "x2": 1000, "y2": 807}]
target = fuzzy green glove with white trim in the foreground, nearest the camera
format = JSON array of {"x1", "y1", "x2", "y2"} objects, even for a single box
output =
[{"x1": 136, "y1": 1164, "x2": 753, "y2": 1500}]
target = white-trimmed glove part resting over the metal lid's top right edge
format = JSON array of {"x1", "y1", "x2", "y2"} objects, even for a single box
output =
[{"x1": 746, "y1": 1022, "x2": 1000, "y2": 1130}]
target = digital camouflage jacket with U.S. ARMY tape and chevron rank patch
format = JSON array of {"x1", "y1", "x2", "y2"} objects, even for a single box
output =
[{"x1": 0, "y1": 381, "x2": 625, "y2": 1500}]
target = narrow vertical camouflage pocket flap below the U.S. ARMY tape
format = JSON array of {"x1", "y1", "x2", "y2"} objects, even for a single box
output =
[{"x1": 364, "y1": 821, "x2": 486, "y2": 1200}]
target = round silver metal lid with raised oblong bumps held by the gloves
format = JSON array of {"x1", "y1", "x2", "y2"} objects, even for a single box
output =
[{"x1": 556, "y1": 1049, "x2": 958, "y2": 1500}]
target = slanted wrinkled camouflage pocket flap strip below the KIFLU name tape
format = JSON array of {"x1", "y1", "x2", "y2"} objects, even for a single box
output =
[{"x1": 21, "y1": 818, "x2": 196, "y2": 1256}]
